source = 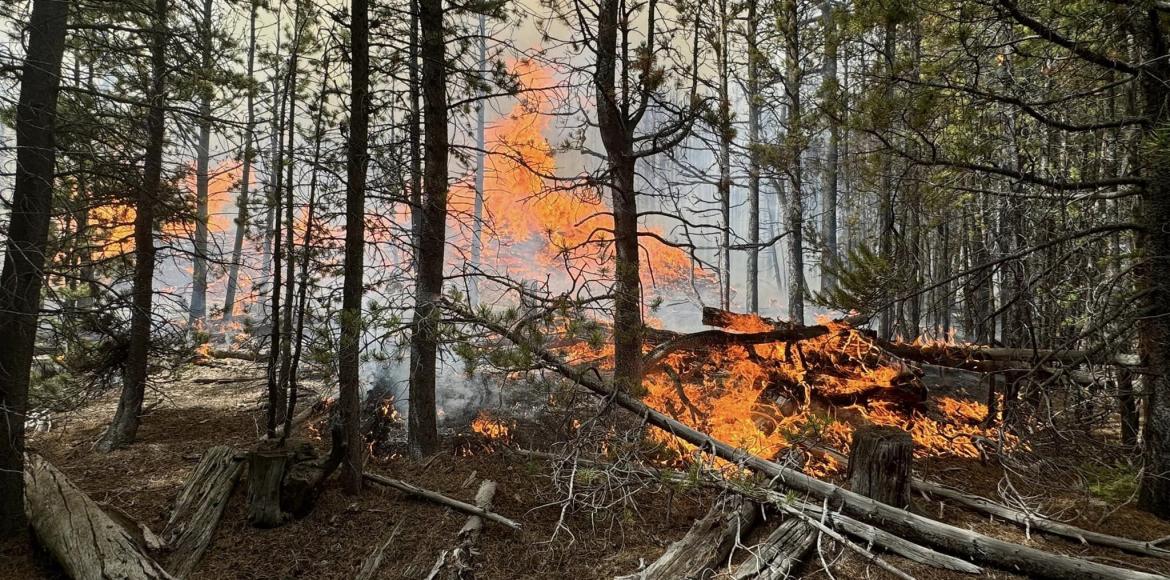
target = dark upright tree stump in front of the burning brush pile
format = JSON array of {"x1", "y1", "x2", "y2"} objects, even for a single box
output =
[{"x1": 849, "y1": 424, "x2": 914, "y2": 508}]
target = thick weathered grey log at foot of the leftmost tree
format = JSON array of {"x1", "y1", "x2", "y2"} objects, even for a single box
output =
[{"x1": 25, "y1": 454, "x2": 174, "y2": 580}]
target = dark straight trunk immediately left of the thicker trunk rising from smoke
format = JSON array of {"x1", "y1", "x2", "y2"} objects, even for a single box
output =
[{"x1": 337, "y1": 0, "x2": 370, "y2": 493}]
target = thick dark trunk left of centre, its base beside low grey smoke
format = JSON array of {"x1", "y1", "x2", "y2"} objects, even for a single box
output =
[{"x1": 407, "y1": 0, "x2": 448, "y2": 457}]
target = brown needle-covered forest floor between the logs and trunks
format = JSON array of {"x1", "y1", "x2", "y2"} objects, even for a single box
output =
[{"x1": 0, "y1": 359, "x2": 1170, "y2": 580}]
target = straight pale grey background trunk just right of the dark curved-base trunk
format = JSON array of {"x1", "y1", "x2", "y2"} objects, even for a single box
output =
[{"x1": 188, "y1": 0, "x2": 214, "y2": 330}]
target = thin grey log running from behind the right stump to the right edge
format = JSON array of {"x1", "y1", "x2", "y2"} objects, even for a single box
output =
[{"x1": 815, "y1": 447, "x2": 1170, "y2": 560}]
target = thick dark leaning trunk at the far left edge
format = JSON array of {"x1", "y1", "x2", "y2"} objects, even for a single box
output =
[{"x1": 0, "y1": 0, "x2": 69, "y2": 538}]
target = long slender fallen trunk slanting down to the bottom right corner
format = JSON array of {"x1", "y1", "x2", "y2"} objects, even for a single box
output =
[{"x1": 443, "y1": 301, "x2": 1164, "y2": 580}]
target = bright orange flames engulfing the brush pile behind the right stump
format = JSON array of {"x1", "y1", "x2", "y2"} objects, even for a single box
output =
[{"x1": 560, "y1": 311, "x2": 1017, "y2": 475}]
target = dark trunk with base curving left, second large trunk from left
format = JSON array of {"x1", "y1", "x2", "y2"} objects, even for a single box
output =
[{"x1": 98, "y1": 0, "x2": 170, "y2": 451}]
